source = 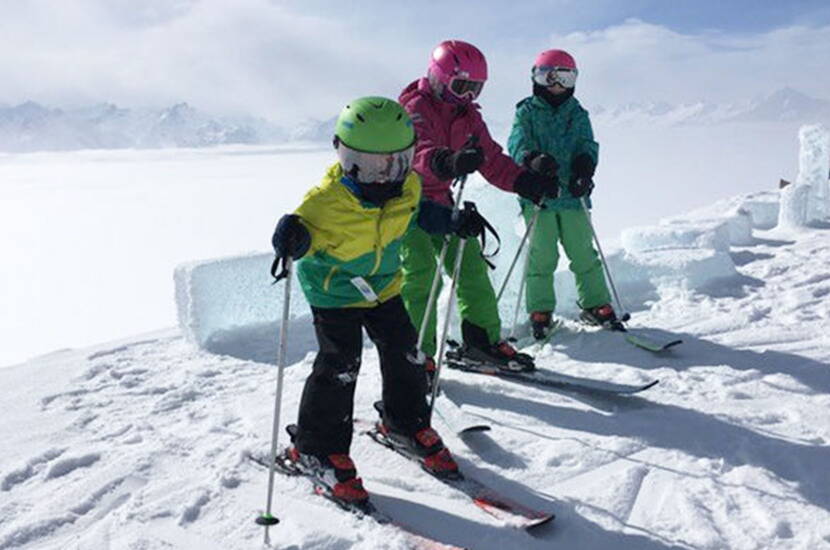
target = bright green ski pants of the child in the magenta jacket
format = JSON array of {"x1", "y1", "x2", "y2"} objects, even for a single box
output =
[{"x1": 401, "y1": 226, "x2": 501, "y2": 357}]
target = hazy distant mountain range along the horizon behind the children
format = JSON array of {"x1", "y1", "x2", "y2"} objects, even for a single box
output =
[{"x1": 0, "y1": 88, "x2": 830, "y2": 152}]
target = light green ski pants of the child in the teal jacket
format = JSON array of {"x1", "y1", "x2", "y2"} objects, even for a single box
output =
[{"x1": 522, "y1": 205, "x2": 611, "y2": 313}]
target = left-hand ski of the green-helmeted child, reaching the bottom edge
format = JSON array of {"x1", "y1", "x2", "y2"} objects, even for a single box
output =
[{"x1": 246, "y1": 451, "x2": 463, "y2": 550}]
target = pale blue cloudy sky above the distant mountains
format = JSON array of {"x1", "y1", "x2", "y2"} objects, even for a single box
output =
[{"x1": 0, "y1": 0, "x2": 830, "y2": 123}]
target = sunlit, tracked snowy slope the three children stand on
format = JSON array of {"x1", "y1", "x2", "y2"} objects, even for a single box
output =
[{"x1": 0, "y1": 208, "x2": 830, "y2": 550}]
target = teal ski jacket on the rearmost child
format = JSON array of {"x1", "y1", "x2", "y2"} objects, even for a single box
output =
[{"x1": 507, "y1": 96, "x2": 599, "y2": 210}]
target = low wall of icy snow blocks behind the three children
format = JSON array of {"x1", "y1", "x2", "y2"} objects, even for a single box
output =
[{"x1": 174, "y1": 189, "x2": 778, "y2": 354}]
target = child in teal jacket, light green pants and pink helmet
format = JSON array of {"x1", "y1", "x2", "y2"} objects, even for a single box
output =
[{"x1": 508, "y1": 50, "x2": 616, "y2": 339}]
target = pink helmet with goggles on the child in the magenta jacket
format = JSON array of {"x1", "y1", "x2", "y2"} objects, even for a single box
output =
[{"x1": 427, "y1": 40, "x2": 487, "y2": 103}]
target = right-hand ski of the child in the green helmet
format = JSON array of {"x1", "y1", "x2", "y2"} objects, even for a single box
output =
[{"x1": 363, "y1": 403, "x2": 556, "y2": 531}]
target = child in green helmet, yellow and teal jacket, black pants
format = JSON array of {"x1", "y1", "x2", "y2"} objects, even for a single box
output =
[{"x1": 272, "y1": 97, "x2": 458, "y2": 502}]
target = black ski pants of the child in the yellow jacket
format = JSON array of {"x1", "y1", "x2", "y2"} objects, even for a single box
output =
[{"x1": 294, "y1": 296, "x2": 429, "y2": 456}]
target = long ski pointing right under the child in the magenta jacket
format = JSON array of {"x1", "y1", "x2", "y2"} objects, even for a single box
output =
[{"x1": 446, "y1": 347, "x2": 659, "y2": 395}]
